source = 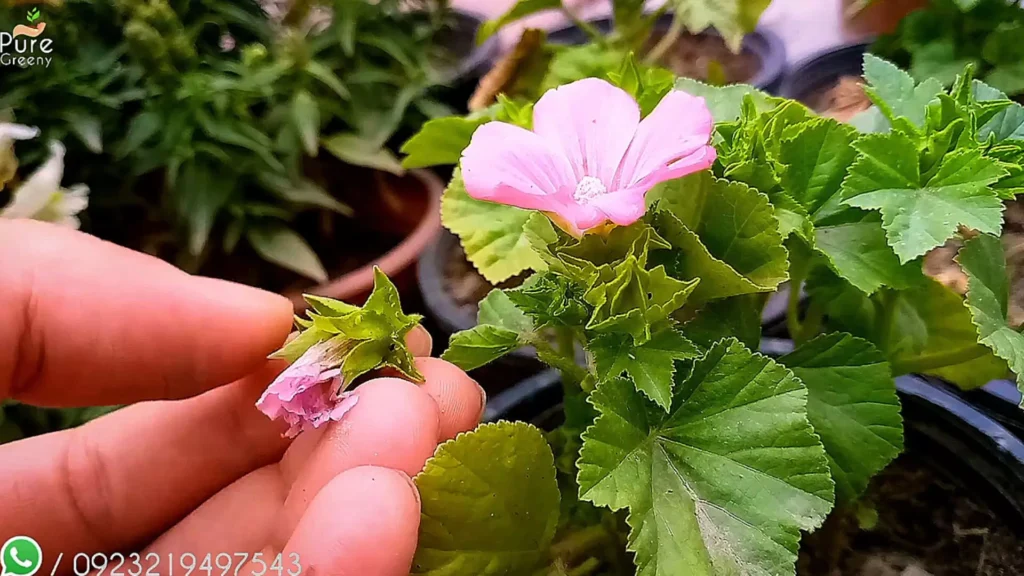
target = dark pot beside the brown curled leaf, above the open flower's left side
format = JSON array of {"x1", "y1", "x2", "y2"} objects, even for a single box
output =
[{"x1": 439, "y1": 10, "x2": 501, "y2": 113}]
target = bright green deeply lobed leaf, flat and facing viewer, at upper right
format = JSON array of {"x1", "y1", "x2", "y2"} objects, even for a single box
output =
[{"x1": 843, "y1": 131, "x2": 1009, "y2": 263}]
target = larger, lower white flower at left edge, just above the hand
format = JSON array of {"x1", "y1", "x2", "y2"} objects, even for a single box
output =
[{"x1": 0, "y1": 141, "x2": 89, "y2": 229}]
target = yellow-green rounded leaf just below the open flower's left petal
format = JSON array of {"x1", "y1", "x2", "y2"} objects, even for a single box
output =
[{"x1": 441, "y1": 170, "x2": 544, "y2": 284}]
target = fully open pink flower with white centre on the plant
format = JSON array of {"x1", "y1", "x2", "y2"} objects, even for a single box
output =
[{"x1": 462, "y1": 78, "x2": 715, "y2": 235}]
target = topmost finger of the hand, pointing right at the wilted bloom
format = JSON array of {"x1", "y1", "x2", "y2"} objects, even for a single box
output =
[{"x1": 0, "y1": 220, "x2": 292, "y2": 406}]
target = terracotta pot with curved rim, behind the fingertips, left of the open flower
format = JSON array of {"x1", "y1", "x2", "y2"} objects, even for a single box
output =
[{"x1": 285, "y1": 170, "x2": 444, "y2": 313}]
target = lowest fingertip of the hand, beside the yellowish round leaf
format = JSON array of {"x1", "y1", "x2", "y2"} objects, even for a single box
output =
[{"x1": 284, "y1": 466, "x2": 420, "y2": 576}]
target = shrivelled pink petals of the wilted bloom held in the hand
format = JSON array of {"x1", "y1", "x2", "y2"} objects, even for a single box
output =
[{"x1": 256, "y1": 342, "x2": 359, "y2": 438}]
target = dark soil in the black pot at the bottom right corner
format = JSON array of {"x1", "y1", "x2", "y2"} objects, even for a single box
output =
[{"x1": 797, "y1": 452, "x2": 1024, "y2": 576}]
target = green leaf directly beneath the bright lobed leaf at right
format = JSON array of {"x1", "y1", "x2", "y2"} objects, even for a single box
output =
[{"x1": 814, "y1": 220, "x2": 922, "y2": 294}]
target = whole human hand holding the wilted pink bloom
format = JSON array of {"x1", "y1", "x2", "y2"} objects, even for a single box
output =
[{"x1": 0, "y1": 220, "x2": 483, "y2": 576}]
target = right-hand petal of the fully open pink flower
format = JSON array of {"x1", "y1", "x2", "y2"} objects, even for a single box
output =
[{"x1": 611, "y1": 90, "x2": 715, "y2": 190}]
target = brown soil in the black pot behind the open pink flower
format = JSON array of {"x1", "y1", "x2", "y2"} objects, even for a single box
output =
[{"x1": 647, "y1": 33, "x2": 761, "y2": 84}]
